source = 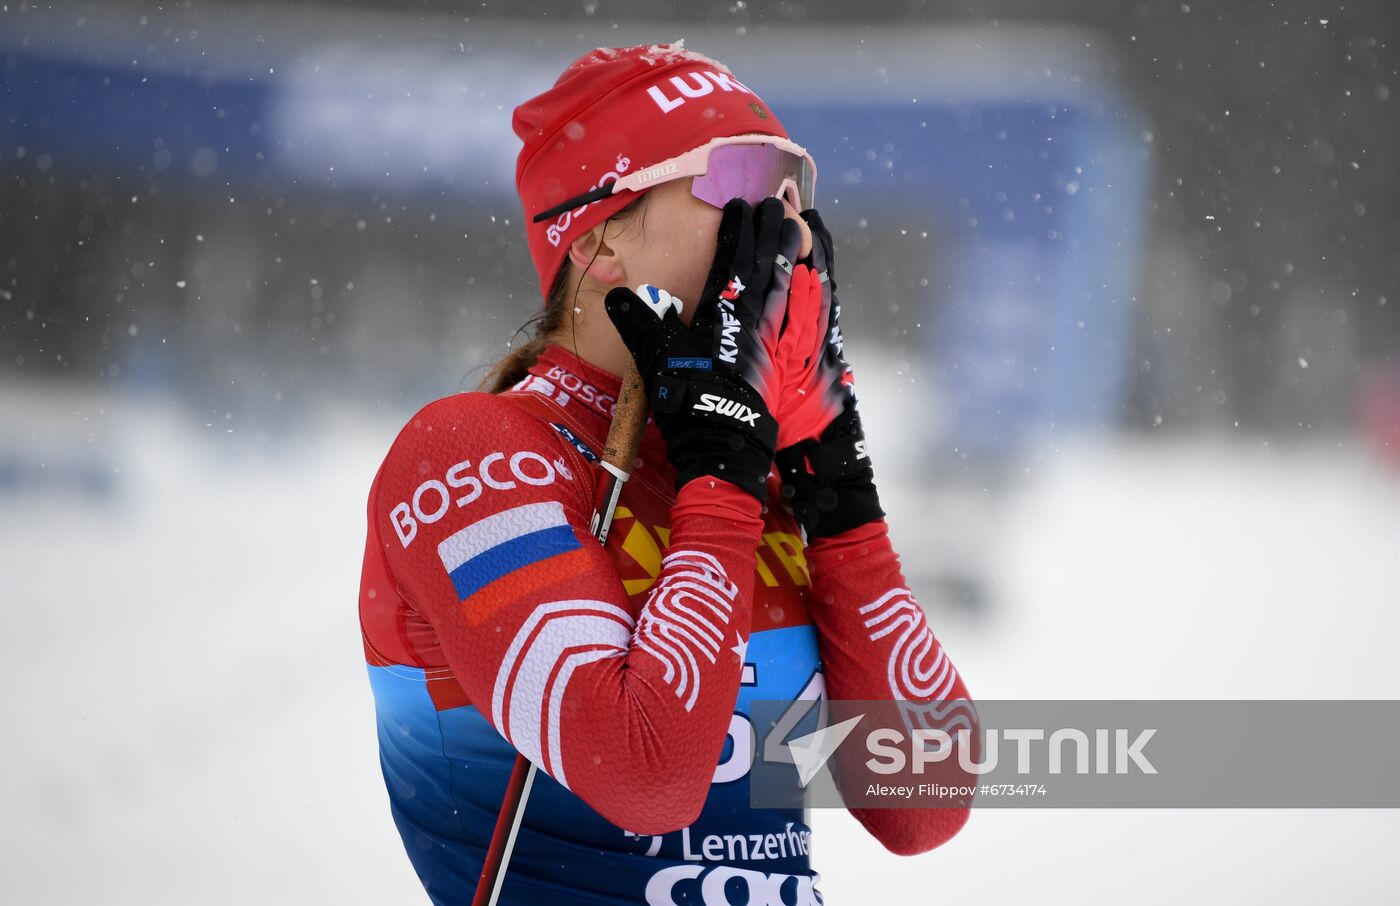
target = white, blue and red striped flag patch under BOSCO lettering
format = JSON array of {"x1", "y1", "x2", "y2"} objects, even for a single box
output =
[{"x1": 438, "y1": 500, "x2": 582, "y2": 613}]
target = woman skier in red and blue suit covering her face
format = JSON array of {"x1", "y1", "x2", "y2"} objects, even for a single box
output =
[{"x1": 360, "y1": 45, "x2": 970, "y2": 906}]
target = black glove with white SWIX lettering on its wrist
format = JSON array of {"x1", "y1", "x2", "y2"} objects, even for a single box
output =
[{"x1": 603, "y1": 199, "x2": 801, "y2": 503}]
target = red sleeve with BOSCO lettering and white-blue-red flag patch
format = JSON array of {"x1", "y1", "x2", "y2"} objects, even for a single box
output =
[{"x1": 370, "y1": 393, "x2": 763, "y2": 835}]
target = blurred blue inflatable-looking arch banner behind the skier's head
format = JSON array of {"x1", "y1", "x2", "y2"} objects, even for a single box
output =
[{"x1": 0, "y1": 19, "x2": 1151, "y2": 462}]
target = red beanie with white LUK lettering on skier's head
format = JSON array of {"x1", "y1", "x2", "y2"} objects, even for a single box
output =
[{"x1": 512, "y1": 41, "x2": 788, "y2": 301}]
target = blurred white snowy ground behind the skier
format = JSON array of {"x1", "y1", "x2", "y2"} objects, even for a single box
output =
[{"x1": 0, "y1": 369, "x2": 1400, "y2": 906}]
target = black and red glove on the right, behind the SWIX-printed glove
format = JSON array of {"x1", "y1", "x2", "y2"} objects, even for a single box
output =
[{"x1": 776, "y1": 209, "x2": 885, "y2": 541}]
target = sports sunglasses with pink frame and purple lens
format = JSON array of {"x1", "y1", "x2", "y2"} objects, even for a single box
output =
[{"x1": 533, "y1": 136, "x2": 816, "y2": 223}]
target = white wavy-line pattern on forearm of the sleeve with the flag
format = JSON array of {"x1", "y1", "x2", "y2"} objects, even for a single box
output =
[{"x1": 637, "y1": 550, "x2": 739, "y2": 711}]
